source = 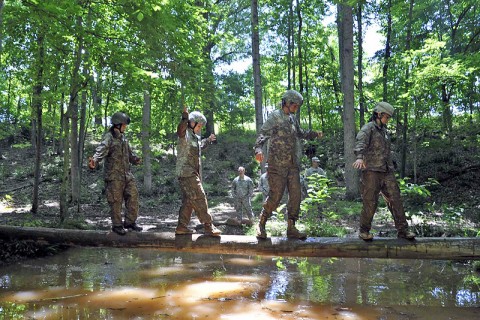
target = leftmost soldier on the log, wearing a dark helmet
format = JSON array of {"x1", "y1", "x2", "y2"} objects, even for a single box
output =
[{"x1": 88, "y1": 112, "x2": 142, "y2": 235}]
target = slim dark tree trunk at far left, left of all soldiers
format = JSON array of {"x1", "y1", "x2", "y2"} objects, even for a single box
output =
[{"x1": 31, "y1": 33, "x2": 45, "y2": 214}]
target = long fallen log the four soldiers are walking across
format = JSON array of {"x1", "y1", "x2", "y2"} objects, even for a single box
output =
[{"x1": 0, "y1": 226, "x2": 480, "y2": 260}]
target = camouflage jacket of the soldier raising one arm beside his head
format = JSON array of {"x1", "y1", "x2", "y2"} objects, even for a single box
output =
[{"x1": 175, "y1": 112, "x2": 209, "y2": 179}]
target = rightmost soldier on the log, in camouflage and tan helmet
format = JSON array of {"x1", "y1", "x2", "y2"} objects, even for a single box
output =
[{"x1": 353, "y1": 102, "x2": 415, "y2": 241}]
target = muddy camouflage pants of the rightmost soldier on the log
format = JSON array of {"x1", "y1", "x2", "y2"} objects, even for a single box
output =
[{"x1": 360, "y1": 170, "x2": 408, "y2": 232}]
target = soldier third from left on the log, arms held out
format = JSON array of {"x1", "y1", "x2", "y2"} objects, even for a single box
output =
[{"x1": 255, "y1": 90, "x2": 322, "y2": 239}]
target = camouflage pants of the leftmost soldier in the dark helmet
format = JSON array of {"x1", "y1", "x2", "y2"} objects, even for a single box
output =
[{"x1": 105, "y1": 178, "x2": 139, "y2": 227}]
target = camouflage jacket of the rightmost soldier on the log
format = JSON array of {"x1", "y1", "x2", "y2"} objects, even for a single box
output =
[{"x1": 354, "y1": 121, "x2": 394, "y2": 172}]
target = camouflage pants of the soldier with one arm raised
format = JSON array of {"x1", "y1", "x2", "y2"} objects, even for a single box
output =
[{"x1": 178, "y1": 176, "x2": 212, "y2": 227}]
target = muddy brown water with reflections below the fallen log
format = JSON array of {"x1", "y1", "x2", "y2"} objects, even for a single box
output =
[{"x1": 0, "y1": 248, "x2": 480, "y2": 320}]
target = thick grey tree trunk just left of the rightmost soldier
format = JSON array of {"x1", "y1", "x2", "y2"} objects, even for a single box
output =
[{"x1": 338, "y1": 4, "x2": 359, "y2": 200}]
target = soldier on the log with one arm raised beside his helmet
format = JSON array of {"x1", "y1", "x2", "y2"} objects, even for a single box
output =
[{"x1": 175, "y1": 108, "x2": 221, "y2": 237}]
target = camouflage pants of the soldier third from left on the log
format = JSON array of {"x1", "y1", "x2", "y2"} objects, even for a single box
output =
[{"x1": 262, "y1": 164, "x2": 302, "y2": 221}]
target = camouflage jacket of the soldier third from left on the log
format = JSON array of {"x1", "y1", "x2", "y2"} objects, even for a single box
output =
[{"x1": 255, "y1": 109, "x2": 317, "y2": 167}]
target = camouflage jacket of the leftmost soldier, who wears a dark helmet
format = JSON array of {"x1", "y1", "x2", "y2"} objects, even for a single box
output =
[{"x1": 93, "y1": 130, "x2": 140, "y2": 181}]
